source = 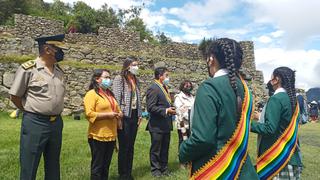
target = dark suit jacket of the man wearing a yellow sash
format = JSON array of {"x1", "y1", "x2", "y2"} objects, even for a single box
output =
[{"x1": 146, "y1": 83, "x2": 172, "y2": 133}]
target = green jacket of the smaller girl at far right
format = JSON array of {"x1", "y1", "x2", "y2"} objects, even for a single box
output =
[{"x1": 251, "y1": 92, "x2": 302, "y2": 166}]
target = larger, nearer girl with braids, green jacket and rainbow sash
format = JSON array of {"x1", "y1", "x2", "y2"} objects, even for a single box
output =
[{"x1": 179, "y1": 38, "x2": 258, "y2": 179}]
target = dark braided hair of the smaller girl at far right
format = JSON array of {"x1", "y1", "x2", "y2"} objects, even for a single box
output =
[{"x1": 272, "y1": 66, "x2": 297, "y2": 113}]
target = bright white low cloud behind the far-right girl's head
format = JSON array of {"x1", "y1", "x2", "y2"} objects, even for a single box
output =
[{"x1": 255, "y1": 48, "x2": 320, "y2": 90}]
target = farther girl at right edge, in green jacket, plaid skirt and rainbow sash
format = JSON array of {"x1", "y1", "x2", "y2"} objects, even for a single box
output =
[{"x1": 251, "y1": 67, "x2": 302, "y2": 179}]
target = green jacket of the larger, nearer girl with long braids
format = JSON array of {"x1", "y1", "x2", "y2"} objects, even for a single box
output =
[{"x1": 179, "y1": 75, "x2": 258, "y2": 180}]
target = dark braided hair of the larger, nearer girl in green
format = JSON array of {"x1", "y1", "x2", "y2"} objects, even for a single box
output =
[{"x1": 209, "y1": 38, "x2": 243, "y2": 115}]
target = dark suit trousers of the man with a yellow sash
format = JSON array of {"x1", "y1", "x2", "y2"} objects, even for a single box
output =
[{"x1": 150, "y1": 132, "x2": 170, "y2": 175}]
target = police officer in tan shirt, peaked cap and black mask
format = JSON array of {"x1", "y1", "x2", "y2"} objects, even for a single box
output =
[{"x1": 9, "y1": 34, "x2": 66, "y2": 180}]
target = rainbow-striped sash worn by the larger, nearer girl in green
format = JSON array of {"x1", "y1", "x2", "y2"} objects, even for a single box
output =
[{"x1": 190, "y1": 78, "x2": 253, "y2": 179}]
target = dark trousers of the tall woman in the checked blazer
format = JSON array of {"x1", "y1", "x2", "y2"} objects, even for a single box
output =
[{"x1": 118, "y1": 110, "x2": 138, "y2": 179}]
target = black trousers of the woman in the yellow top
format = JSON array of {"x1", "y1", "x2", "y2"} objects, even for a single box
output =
[{"x1": 88, "y1": 138, "x2": 115, "y2": 180}]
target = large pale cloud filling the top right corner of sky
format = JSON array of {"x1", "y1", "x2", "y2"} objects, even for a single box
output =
[{"x1": 245, "y1": 0, "x2": 320, "y2": 49}]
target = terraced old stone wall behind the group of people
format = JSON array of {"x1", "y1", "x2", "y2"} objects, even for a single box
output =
[{"x1": 0, "y1": 15, "x2": 266, "y2": 114}]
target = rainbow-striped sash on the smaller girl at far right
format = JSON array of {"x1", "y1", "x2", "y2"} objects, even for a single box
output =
[{"x1": 257, "y1": 104, "x2": 299, "y2": 179}]
